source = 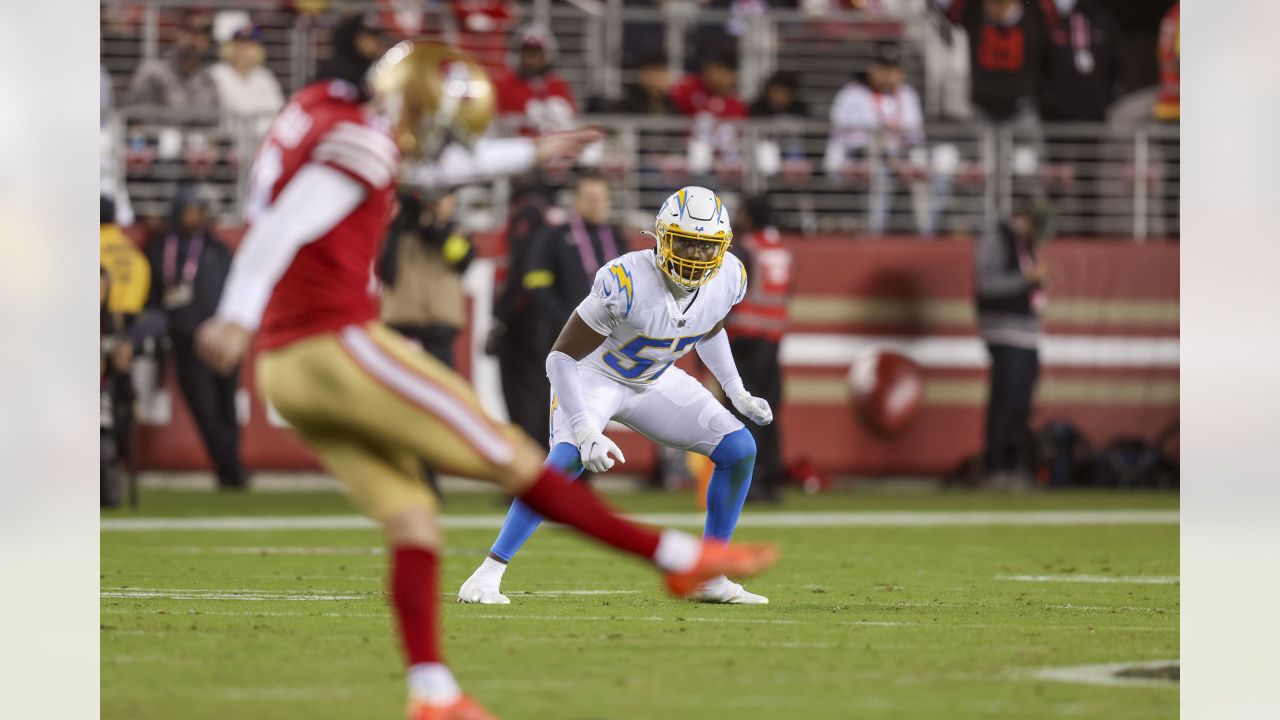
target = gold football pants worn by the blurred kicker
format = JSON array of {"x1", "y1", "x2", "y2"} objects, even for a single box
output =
[{"x1": 257, "y1": 323, "x2": 530, "y2": 520}]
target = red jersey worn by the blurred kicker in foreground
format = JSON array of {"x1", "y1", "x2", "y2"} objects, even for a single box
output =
[{"x1": 246, "y1": 81, "x2": 399, "y2": 348}]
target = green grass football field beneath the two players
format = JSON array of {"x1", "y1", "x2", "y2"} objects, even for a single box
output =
[{"x1": 101, "y1": 491, "x2": 1179, "y2": 720}]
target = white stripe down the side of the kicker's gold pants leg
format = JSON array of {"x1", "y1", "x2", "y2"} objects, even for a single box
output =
[{"x1": 342, "y1": 325, "x2": 515, "y2": 465}]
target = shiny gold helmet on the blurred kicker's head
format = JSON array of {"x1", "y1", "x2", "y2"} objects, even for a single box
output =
[{"x1": 369, "y1": 41, "x2": 498, "y2": 159}]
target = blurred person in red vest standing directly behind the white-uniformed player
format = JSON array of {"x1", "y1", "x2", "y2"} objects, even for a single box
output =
[{"x1": 724, "y1": 195, "x2": 792, "y2": 502}]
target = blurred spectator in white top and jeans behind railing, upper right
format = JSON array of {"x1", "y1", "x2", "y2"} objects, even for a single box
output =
[{"x1": 823, "y1": 42, "x2": 952, "y2": 236}]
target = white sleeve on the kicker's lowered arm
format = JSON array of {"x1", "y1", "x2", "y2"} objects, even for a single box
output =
[{"x1": 218, "y1": 164, "x2": 365, "y2": 331}]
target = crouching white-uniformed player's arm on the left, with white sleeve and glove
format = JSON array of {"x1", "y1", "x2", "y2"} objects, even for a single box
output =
[{"x1": 547, "y1": 312, "x2": 627, "y2": 473}]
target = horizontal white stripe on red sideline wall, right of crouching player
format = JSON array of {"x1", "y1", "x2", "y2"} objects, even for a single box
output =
[{"x1": 781, "y1": 333, "x2": 1179, "y2": 368}]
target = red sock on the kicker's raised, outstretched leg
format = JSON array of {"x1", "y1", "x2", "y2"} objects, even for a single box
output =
[{"x1": 520, "y1": 468, "x2": 658, "y2": 559}]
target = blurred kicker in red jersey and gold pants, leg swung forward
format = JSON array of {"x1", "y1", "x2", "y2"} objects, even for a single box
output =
[{"x1": 197, "y1": 20, "x2": 777, "y2": 720}]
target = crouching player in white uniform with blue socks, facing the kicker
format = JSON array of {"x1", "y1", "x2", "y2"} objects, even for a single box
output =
[{"x1": 458, "y1": 187, "x2": 773, "y2": 605}]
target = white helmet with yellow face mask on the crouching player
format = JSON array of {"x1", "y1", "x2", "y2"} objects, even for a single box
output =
[{"x1": 653, "y1": 186, "x2": 733, "y2": 288}]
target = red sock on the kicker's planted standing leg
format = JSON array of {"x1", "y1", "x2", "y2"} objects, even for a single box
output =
[{"x1": 390, "y1": 546, "x2": 443, "y2": 666}]
